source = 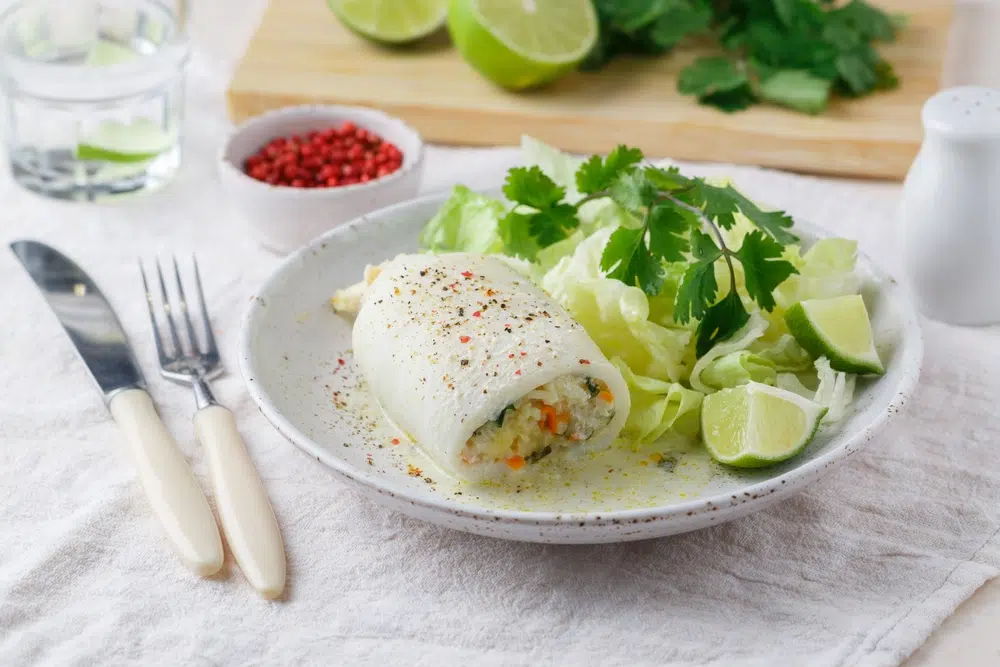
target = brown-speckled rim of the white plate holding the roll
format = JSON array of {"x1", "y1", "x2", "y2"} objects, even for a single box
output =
[{"x1": 239, "y1": 193, "x2": 924, "y2": 528}]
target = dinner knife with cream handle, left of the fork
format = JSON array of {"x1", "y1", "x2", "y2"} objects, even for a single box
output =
[{"x1": 10, "y1": 241, "x2": 223, "y2": 576}]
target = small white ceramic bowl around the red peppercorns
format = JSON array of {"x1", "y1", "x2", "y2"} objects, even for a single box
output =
[{"x1": 219, "y1": 105, "x2": 424, "y2": 254}]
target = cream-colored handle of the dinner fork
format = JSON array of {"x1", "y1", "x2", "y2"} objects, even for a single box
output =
[{"x1": 194, "y1": 405, "x2": 285, "y2": 599}]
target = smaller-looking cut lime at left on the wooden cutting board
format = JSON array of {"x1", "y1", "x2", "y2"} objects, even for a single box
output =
[{"x1": 326, "y1": 0, "x2": 448, "y2": 44}]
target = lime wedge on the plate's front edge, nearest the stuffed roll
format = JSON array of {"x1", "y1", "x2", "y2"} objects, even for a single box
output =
[{"x1": 701, "y1": 382, "x2": 826, "y2": 468}]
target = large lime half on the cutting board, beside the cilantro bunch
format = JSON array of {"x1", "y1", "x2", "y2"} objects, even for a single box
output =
[{"x1": 448, "y1": 0, "x2": 598, "y2": 90}]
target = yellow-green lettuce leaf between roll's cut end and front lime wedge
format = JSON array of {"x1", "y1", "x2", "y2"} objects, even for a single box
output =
[{"x1": 611, "y1": 357, "x2": 703, "y2": 444}]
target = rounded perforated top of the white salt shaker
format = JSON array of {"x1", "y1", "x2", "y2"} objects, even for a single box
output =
[{"x1": 921, "y1": 86, "x2": 1000, "y2": 140}]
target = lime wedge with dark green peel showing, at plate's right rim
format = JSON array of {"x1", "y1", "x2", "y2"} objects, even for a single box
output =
[{"x1": 785, "y1": 294, "x2": 885, "y2": 375}]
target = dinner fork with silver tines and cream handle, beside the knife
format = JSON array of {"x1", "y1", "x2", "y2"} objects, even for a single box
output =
[{"x1": 139, "y1": 257, "x2": 285, "y2": 598}]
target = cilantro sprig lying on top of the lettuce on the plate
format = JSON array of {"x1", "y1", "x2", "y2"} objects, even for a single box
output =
[{"x1": 500, "y1": 146, "x2": 798, "y2": 356}]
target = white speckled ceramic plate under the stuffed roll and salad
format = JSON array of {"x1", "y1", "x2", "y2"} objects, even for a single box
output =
[{"x1": 240, "y1": 195, "x2": 923, "y2": 543}]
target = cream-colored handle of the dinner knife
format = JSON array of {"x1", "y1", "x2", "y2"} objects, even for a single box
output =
[{"x1": 109, "y1": 389, "x2": 222, "y2": 577}]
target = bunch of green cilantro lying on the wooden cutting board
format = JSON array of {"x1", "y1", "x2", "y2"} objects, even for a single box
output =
[{"x1": 583, "y1": 0, "x2": 905, "y2": 114}]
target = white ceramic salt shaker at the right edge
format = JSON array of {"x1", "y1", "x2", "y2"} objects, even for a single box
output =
[{"x1": 900, "y1": 86, "x2": 1000, "y2": 325}]
